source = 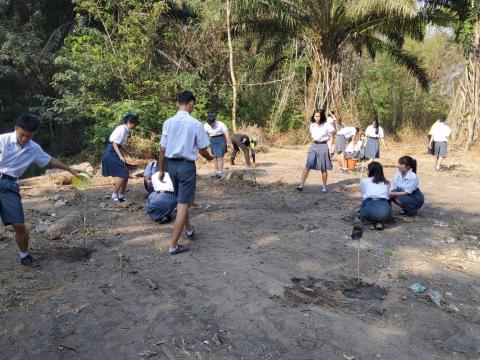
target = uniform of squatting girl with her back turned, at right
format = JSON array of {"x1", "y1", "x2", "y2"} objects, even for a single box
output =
[{"x1": 360, "y1": 177, "x2": 392, "y2": 223}]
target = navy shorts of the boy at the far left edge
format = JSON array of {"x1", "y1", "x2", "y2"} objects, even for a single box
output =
[{"x1": 0, "y1": 179, "x2": 25, "y2": 226}]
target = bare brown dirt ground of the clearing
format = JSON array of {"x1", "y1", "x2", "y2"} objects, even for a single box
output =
[{"x1": 0, "y1": 144, "x2": 480, "y2": 360}]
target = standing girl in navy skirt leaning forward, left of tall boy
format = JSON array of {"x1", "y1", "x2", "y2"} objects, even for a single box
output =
[{"x1": 102, "y1": 113, "x2": 140, "y2": 202}]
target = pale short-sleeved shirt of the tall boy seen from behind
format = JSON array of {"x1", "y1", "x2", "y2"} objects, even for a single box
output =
[{"x1": 160, "y1": 110, "x2": 210, "y2": 161}]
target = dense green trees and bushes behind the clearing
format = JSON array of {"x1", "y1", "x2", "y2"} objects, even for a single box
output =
[{"x1": 0, "y1": 0, "x2": 469, "y2": 156}]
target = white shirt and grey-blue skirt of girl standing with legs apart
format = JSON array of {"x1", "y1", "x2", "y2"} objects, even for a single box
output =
[{"x1": 305, "y1": 122, "x2": 335, "y2": 172}]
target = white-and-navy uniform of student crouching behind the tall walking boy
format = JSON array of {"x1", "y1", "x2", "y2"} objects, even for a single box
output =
[{"x1": 145, "y1": 172, "x2": 177, "y2": 221}]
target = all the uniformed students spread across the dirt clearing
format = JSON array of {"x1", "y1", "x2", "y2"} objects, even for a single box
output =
[{"x1": 0, "y1": 91, "x2": 450, "y2": 267}]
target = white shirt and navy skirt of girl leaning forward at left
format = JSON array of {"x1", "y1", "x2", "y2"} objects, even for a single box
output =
[{"x1": 102, "y1": 124, "x2": 130, "y2": 180}]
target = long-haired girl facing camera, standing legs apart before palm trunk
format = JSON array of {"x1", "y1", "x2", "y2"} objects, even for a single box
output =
[{"x1": 296, "y1": 109, "x2": 335, "y2": 193}]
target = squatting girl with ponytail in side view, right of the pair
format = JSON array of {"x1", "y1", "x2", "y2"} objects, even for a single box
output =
[{"x1": 388, "y1": 156, "x2": 425, "y2": 216}]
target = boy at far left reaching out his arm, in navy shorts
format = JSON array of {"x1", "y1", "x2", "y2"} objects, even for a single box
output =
[{"x1": 0, "y1": 114, "x2": 80, "y2": 267}]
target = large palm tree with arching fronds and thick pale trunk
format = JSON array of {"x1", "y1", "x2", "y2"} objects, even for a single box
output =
[{"x1": 235, "y1": 0, "x2": 428, "y2": 117}]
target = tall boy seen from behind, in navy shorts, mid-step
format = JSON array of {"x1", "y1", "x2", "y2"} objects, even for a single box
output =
[{"x1": 158, "y1": 91, "x2": 213, "y2": 255}]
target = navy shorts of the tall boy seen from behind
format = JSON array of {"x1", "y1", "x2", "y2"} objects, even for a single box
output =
[{"x1": 167, "y1": 159, "x2": 197, "y2": 204}]
